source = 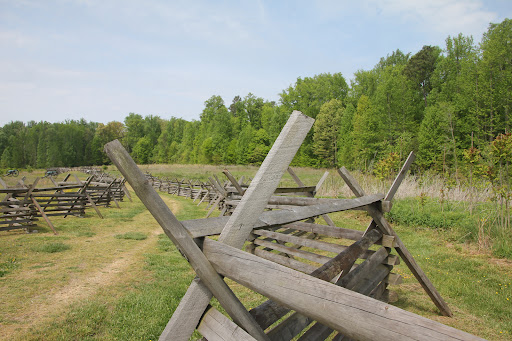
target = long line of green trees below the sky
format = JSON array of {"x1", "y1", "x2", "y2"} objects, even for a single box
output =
[{"x1": 0, "y1": 19, "x2": 512, "y2": 172}]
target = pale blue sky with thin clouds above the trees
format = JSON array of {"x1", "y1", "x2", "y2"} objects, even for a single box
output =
[{"x1": 0, "y1": 0, "x2": 512, "y2": 126}]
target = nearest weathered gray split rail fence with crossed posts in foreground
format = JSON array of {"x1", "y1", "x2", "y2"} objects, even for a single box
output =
[{"x1": 105, "y1": 111, "x2": 481, "y2": 341}]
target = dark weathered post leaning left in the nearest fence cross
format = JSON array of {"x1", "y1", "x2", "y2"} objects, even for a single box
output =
[{"x1": 105, "y1": 140, "x2": 267, "y2": 340}]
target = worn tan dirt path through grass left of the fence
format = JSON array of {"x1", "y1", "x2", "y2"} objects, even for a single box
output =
[{"x1": 0, "y1": 198, "x2": 180, "y2": 340}]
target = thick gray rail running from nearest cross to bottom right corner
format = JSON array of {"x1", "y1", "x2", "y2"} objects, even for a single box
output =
[{"x1": 203, "y1": 239, "x2": 482, "y2": 341}]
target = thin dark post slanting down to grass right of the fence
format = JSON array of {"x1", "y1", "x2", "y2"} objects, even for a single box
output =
[{"x1": 338, "y1": 167, "x2": 452, "y2": 316}]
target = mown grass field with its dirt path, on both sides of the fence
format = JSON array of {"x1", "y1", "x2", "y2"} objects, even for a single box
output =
[{"x1": 0, "y1": 166, "x2": 512, "y2": 340}]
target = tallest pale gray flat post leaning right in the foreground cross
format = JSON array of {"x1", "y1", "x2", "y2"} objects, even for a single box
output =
[{"x1": 160, "y1": 111, "x2": 314, "y2": 341}]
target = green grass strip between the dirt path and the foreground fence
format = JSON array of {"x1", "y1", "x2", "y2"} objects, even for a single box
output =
[{"x1": 19, "y1": 194, "x2": 197, "y2": 340}]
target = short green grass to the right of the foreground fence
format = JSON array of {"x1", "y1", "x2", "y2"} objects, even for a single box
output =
[{"x1": 395, "y1": 226, "x2": 512, "y2": 339}]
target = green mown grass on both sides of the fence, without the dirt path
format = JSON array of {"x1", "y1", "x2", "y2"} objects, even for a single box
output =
[{"x1": 0, "y1": 179, "x2": 512, "y2": 340}]
